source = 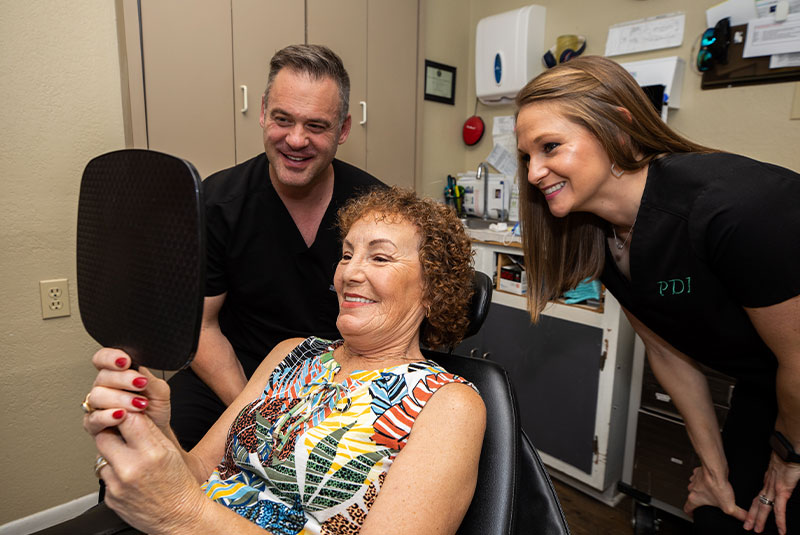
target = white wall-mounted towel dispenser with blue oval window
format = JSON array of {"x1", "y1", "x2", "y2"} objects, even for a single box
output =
[{"x1": 475, "y1": 5, "x2": 547, "y2": 104}]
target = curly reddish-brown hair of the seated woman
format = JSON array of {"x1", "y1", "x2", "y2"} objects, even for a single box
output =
[{"x1": 337, "y1": 186, "x2": 475, "y2": 348}]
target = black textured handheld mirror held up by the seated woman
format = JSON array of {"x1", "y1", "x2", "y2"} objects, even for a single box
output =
[{"x1": 77, "y1": 149, "x2": 205, "y2": 370}]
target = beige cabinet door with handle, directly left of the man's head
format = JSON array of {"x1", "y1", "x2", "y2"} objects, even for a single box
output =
[{"x1": 231, "y1": 0, "x2": 305, "y2": 163}]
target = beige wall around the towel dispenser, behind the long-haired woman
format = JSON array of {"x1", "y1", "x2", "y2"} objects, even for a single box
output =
[{"x1": 418, "y1": 0, "x2": 800, "y2": 198}]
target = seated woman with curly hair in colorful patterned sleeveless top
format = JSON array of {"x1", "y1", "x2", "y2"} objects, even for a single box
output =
[{"x1": 84, "y1": 188, "x2": 485, "y2": 535}]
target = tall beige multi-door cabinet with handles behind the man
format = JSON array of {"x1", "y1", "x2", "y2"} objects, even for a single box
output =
[{"x1": 119, "y1": 0, "x2": 419, "y2": 187}]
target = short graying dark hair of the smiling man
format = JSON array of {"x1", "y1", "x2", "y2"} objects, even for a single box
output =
[{"x1": 264, "y1": 45, "x2": 350, "y2": 126}]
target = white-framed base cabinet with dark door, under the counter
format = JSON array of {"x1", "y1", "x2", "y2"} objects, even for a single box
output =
[{"x1": 466, "y1": 237, "x2": 634, "y2": 503}]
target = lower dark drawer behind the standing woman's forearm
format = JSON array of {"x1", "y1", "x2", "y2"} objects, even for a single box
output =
[{"x1": 632, "y1": 411, "x2": 700, "y2": 509}]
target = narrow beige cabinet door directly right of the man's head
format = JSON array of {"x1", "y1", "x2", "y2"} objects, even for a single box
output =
[{"x1": 306, "y1": 0, "x2": 368, "y2": 171}]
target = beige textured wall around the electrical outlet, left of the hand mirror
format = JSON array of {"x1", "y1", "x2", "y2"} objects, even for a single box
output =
[{"x1": 0, "y1": 0, "x2": 124, "y2": 524}]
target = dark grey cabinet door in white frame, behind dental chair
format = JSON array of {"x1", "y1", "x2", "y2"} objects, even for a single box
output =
[{"x1": 456, "y1": 303, "x2": 603, "y2": 474}]
